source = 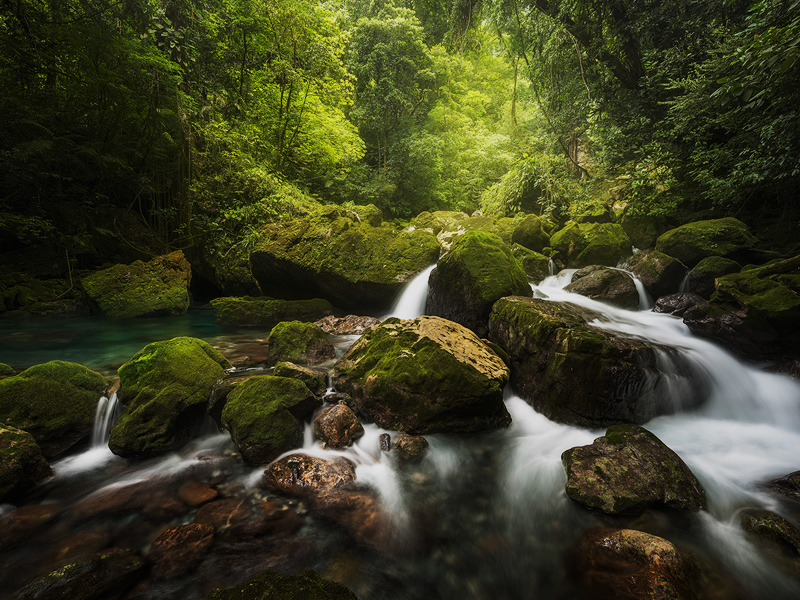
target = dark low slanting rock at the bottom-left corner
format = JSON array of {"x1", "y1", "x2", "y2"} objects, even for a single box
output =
[{"x1": 14, "y1": 548, "x2": 149, "y2": 600}]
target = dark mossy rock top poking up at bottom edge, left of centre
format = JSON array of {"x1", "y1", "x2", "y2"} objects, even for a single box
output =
[{"x1": 205, "y1": 569, "x2": 357, "y2": 600}]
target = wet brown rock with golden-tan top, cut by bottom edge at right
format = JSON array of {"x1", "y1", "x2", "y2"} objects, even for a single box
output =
[{"x1": 571, "y1": 527, "x2": 745, "y2": 600}]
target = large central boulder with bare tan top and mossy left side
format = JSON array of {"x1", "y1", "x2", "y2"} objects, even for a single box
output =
[{"x1": 331, "y1": 316, "x2": 511, "y2": 434}]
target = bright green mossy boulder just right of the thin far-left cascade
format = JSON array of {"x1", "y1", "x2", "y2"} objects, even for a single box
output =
[{"x1": 108, "y1": 337, "x2": 231, "y2": 458}]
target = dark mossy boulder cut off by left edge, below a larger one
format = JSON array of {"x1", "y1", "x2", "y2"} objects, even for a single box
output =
[{"x1": 0, "y1": 423, "x2": 53, "y2": 503}]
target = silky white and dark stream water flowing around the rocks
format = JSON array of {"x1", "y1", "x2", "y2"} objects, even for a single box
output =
[{"x1": 0, "y1": 268, "x2": 800, "y2": 600}]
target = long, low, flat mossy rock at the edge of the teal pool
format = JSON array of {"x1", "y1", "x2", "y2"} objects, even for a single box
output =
[{"x1": 211, "y1": 296, "x2": 334, "y2": 329}]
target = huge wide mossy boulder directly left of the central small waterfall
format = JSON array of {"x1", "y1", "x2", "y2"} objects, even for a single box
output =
[{"x1": 250, "y1": 216, "x2": 439, "y2": 309}]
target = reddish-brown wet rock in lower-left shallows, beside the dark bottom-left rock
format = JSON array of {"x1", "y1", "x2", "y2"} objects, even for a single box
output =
[{"x1": 147, "y1": 523, "x2": 214, "y2": 579}]
